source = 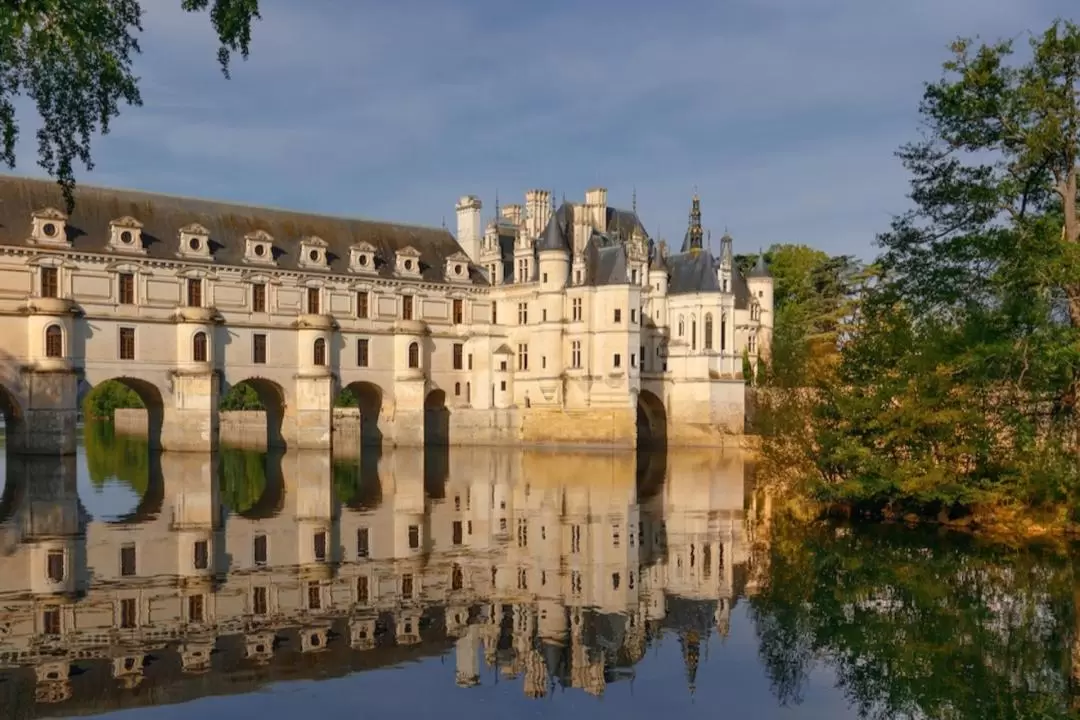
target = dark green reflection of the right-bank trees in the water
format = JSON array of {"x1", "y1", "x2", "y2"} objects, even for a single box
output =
[{"x1": 751, "y1": 526, "x2": 1076, "y2": 719}]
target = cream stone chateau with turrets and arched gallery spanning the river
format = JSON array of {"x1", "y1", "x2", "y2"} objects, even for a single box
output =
[{"x1": 0, "y1": 177, "x2": 772, "y2": 453}]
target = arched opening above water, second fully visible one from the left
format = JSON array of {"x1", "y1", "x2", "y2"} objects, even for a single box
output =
[{"x1": 218, "y1": 378, "x2": 286, "y2": 450}]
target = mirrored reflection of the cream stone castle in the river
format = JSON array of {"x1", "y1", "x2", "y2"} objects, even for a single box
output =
[{"x1": 0, "y1": 449, "x2": 746, "y2": 712}]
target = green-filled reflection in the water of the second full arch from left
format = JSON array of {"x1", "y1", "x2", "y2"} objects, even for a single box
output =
[{"x1": 218, "y1": 448, "x2": 285, "y2": 520}]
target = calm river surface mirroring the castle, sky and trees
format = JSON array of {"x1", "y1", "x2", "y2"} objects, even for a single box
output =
[{"x1": 0, "y1": 429, "x2": 1080, "y2": 719}]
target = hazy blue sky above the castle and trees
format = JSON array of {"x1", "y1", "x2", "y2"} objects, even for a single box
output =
[{"x1": 8, "y1": 0, "x2": 1069, "y2": 257}]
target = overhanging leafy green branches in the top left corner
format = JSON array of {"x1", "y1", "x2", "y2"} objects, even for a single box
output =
[{"x1": 0, "y1": 0, "x2": 259, "y2": 212}]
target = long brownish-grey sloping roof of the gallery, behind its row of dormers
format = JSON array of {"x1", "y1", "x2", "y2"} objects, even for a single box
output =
[{"x1": 0, "y1": 175, "x2": 486, "y2": 284}]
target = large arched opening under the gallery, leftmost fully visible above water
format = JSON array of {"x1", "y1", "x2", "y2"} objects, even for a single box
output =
[{"x1": 80, "y1": 378, "x2": 165, "y2": 451}]
